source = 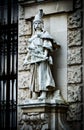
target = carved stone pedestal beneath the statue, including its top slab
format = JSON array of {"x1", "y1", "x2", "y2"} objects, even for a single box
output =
[{"x1": 20, "y1": 100, "x2": 70, "y2": 130}]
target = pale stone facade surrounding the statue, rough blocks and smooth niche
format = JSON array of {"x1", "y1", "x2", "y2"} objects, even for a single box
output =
[{"x1": 18, "y1": 0, "x2": 83, "y2": 130}]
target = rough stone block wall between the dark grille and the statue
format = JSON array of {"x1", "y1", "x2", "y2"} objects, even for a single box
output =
[{"x1": 18, "y1": 6, "x2": 31, "y2": 104}]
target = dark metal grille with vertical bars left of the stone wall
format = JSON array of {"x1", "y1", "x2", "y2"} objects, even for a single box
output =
[{"x1": 0, "y1": 0, "x2": 18, "y2": 130}]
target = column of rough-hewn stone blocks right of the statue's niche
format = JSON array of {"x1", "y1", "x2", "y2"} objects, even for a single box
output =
[{"x1": 67, "y1": 0, "x2": 83, "y2": 130}]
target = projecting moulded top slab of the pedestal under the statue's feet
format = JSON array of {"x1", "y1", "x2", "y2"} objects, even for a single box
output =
[{"x1": 18, "y1": 100, "x2": 68, "y2": 113}]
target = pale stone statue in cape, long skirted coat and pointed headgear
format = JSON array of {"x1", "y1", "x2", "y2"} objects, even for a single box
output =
[{"x1": 24, "y1": 10, "x2": 59, "y2": 99}]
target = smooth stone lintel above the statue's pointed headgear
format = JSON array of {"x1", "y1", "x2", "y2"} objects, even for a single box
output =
[{"x1": 24, "y1": 0, "x2": 73, "y2": 19}]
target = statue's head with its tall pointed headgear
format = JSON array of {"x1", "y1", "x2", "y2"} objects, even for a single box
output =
[{"x1": 33, "y1": 9, "x2": 43, "y2": 30}]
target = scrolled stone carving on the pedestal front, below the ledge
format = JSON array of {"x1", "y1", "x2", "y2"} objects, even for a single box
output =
[{"x1": 21, "y1": 113, "x2": 49, "y2": 130}]
